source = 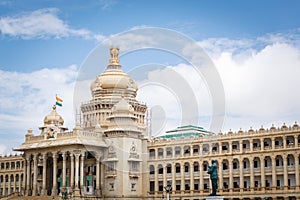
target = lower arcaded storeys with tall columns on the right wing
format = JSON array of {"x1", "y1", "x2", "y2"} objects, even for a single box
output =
[{"x1": 149, "y1": 151, "x2": 300, "y2": 196}]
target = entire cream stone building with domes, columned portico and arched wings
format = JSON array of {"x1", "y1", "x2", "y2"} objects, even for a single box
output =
[{"x1": 0, "y1": 48, "x2": 300, "y2": 200}]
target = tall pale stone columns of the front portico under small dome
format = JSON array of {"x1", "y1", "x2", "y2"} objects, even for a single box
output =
[{"x1": 24, "y1": 150, "x2": 101, "y2": 196}]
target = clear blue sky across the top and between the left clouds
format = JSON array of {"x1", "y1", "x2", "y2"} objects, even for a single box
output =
[{"x1": 0, "y1": 0, "x2": 300, "y2": 72}]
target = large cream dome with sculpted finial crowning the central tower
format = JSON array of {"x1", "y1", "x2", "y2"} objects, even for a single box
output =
[{"x1": 91, "y1": 47, "x2": 138, "y2": 99}]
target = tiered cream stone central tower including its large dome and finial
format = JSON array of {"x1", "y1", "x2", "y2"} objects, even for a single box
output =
[{"x1": 81, "y1": 47, "x2": 147, "y2": 199}]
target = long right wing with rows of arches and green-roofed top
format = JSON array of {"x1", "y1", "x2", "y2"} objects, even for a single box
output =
[{"x1": 148, "y1": 123, "x2": 300, "y2": 200}]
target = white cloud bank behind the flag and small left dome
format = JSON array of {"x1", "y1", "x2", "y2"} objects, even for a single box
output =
[{"x1": 0, "y1": 66, "x2": 77, "y2": 142}]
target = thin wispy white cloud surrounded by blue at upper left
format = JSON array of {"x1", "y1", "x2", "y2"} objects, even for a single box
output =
[{"x1": 0, "y1": 8, "x2": 104, "y2": 41}]
